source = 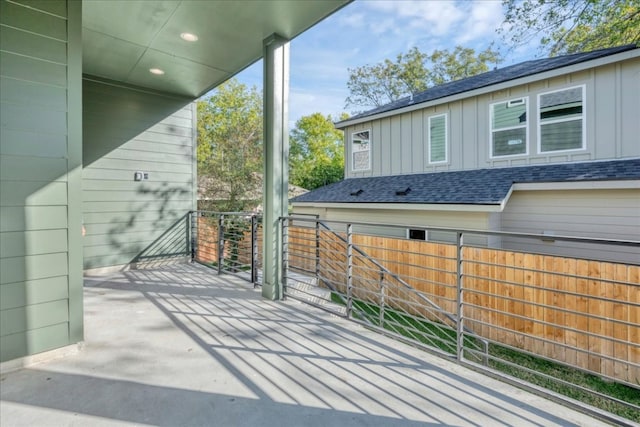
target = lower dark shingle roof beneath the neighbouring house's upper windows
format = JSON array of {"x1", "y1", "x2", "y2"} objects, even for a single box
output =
[{"x1": 291, "y1": 159, "x2": 640, "y2": 205}]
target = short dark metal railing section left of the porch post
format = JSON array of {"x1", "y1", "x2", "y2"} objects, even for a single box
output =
[{"x1": 190, "y1": 211, "x2": 262, "y2": 286}]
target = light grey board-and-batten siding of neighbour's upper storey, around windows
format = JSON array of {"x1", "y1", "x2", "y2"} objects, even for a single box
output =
[{"x1": 338, "y1": 49, "x2": 640, "y2": 178}]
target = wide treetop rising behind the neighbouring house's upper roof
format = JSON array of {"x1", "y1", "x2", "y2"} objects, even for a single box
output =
[{"x1": 345, "y1": 46, "x2": 501, "y2": 108}]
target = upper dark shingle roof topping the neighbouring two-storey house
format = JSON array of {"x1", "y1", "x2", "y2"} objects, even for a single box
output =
[{"x1": 336, "y1": 45, "x2": 637, "y2": 123}]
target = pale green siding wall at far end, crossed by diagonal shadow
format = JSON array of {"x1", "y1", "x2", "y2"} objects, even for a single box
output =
[{"x1": 83, "y1": 76, "x2": 196, "y2": 269}]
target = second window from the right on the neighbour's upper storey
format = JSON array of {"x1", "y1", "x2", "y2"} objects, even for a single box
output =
[{"x1": 491, "y1": 98, "x2": 529, "y2": 157}]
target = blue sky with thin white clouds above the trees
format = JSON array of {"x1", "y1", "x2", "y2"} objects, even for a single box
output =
[{"x1": 225, "y1": 0, "x2": 540, "y2": 128}]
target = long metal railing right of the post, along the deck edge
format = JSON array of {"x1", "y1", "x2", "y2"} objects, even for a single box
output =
[{"x1": 282, "y1": 216, "x2": 640, "y2": 416}]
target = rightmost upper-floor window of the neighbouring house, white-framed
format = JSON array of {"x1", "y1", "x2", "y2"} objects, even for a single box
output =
[{"x1": 538, "y1": 86, "x2": 585, "y2": 153}]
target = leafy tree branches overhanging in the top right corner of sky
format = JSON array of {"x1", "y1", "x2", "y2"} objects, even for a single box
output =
[{"x1": 500, "y1": 0, "x2": 640, "y2": 56}]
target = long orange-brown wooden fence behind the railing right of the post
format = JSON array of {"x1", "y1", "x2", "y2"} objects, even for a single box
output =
[{"x1": 288, "y1": 226, "x2": 640, "y2": 385}]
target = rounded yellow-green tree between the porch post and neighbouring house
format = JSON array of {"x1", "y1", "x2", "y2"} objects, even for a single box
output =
[{"x1": 289, "y1": 113, "x2": 346, "y2": 190}]
